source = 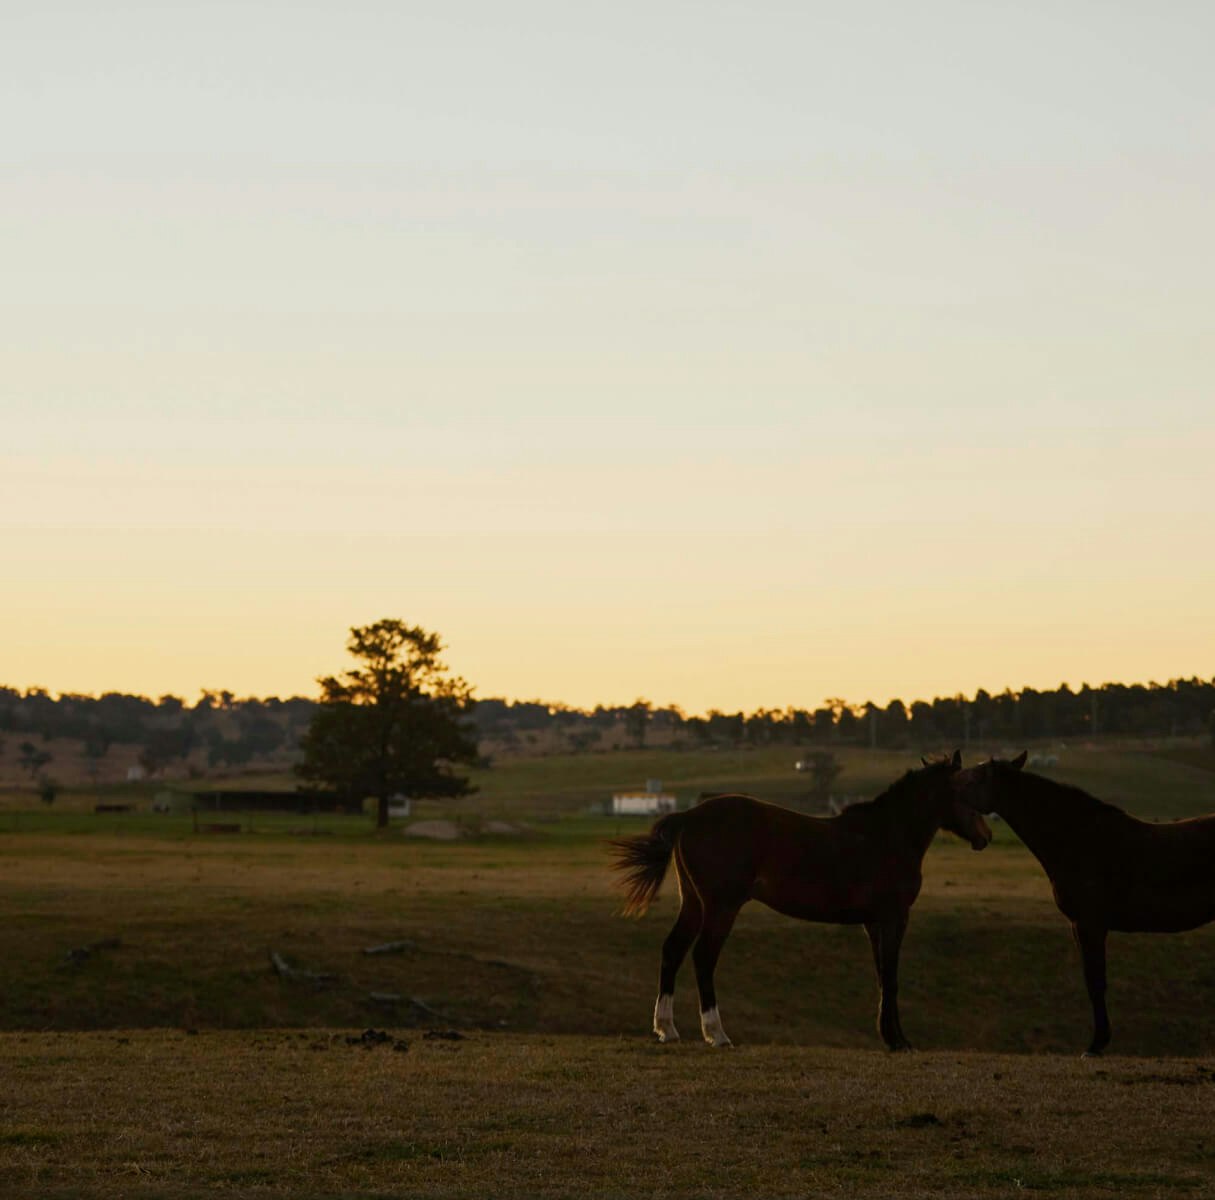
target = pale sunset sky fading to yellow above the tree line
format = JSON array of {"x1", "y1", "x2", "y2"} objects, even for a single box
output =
[{"x1": 0, "y1": 0, "x2": 1215, "y2": 712}]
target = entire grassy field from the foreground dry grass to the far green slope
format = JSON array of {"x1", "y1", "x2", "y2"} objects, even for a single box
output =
[{"x1": 0, "y1": 751, "x2": 1215, "y2": 1196}]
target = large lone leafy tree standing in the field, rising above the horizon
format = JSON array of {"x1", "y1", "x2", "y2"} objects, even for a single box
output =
[{"x1": 296, "y1": 618, "x2": 476, "y2": 826}]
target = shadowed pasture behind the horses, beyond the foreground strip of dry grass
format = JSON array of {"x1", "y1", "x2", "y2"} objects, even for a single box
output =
[{"x1": 0, "y1": 749, "x2": 1215, "y2": 1054}]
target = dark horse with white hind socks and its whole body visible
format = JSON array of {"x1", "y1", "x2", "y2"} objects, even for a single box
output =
[{"x1": 612, "y1": 753, "x2": 991, "y2": 1051}]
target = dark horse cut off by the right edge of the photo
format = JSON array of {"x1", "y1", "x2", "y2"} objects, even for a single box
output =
[{"x1": 955, "y1": 753, "x2": 1215, "y2": 1057}]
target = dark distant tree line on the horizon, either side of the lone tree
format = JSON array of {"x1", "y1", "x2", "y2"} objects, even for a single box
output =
[{"x1": 0, "y1": 678, "x2": 1215, "y2": 775}]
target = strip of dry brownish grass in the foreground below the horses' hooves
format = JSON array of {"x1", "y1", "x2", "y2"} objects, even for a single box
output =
[{"x1": 0, "y1": 1030, "x2": 1215, "y2": 1200}]
